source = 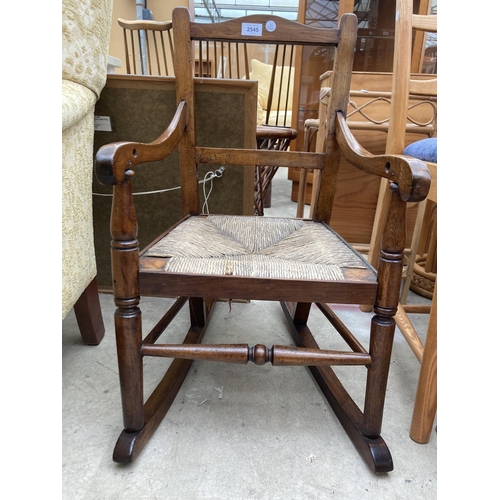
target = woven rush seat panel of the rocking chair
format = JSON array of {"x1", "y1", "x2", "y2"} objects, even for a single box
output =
[{"x1": 143, "y1": 215, "x2": 369, "y2": 281}]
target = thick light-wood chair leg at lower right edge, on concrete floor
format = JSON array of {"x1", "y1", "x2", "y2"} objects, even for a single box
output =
[{"x1": 410, "y1": 285, "x2": 437, "y2": 444}]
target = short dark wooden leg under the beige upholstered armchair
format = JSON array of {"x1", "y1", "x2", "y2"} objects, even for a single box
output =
[{"x1": 74, "y1": 278, "x2": 105, "y2": 345}]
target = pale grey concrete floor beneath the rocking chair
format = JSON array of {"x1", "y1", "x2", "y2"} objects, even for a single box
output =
[{"x1": 62, "y1": 170, "x2": 437, "y2": 500}]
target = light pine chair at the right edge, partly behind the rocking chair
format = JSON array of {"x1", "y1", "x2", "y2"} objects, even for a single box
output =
[{"x1": 368, "y1": 0, "x2": 437, "y2": 443}]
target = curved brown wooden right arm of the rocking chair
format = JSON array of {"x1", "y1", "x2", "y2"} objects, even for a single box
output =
[{"x1": 335, "y1": 111, "x2": 431, "y2": 202}]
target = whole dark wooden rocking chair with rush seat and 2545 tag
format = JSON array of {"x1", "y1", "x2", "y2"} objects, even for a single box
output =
[{"x1": 96, "y1": 7, "x2": 430, "y2": 472}]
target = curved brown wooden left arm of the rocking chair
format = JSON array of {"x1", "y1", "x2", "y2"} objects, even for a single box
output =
[{"x1": 95, "y1": 101, "x2": 187, "y2": 184}]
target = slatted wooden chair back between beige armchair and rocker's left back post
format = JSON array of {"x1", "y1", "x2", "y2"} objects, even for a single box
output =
[{"x1": 118, "y1": 19, "x2": 174, "y2": 76}]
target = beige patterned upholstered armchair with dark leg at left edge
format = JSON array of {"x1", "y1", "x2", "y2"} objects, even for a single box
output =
[{"x1": 62, "y1": 0, "x2": 113, "y2": 344}]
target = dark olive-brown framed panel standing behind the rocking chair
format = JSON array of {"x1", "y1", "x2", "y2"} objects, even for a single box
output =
[{"x1": 93, "y1": 75, "x2": 257, "y2": 290}]
